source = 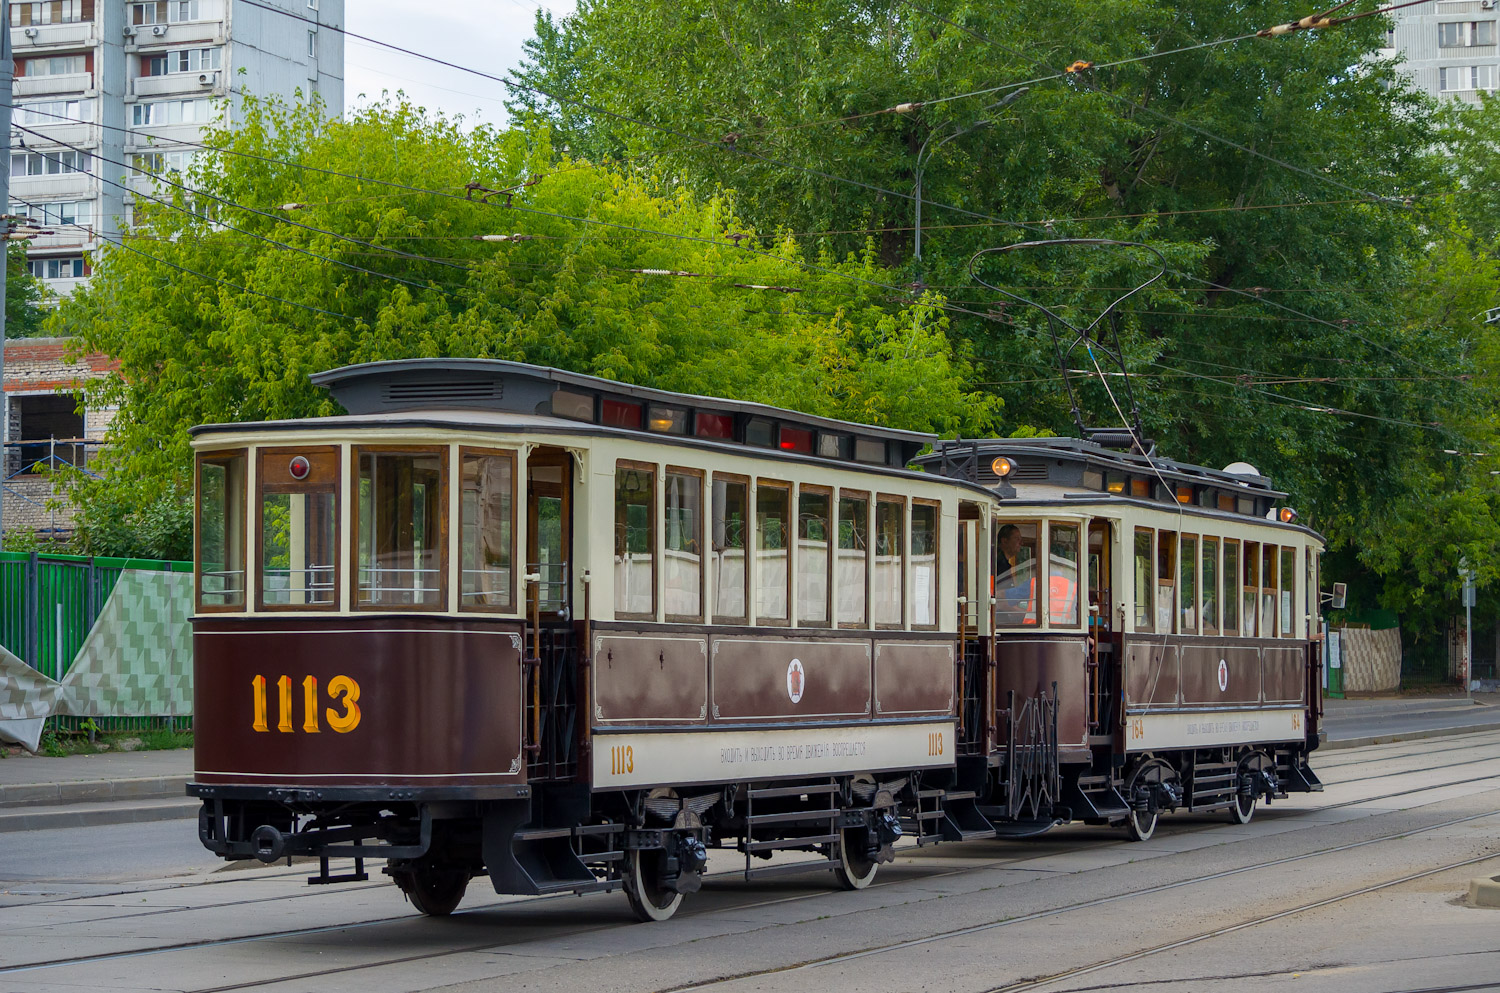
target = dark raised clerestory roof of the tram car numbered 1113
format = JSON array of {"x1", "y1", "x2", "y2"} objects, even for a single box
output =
[{"x1": 297, "y1": 359, "x2": 938, "y2": 468}]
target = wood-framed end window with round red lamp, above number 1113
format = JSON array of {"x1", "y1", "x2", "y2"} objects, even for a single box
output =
[{"x1": 258, "y1": 447, "x2": 339, "y2": 611}]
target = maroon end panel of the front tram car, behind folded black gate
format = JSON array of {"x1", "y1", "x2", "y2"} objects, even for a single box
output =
[{"x1": 995, "y1": 635, "x2": 1089, "y2": 762}]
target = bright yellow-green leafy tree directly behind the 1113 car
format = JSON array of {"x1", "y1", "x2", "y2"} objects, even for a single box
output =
[{"x1": 57, "y1": 101, "x2": 999, "y2": 552}]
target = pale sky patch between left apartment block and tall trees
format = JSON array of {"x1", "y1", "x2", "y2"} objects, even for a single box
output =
[{"x1": 344, "y1": 0, "x2": 573, "y2": 125}]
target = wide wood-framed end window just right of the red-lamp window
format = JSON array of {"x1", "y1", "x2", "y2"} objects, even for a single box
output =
[{"x1": 354, "y1": 449, "x2": 447, "y2": 609}]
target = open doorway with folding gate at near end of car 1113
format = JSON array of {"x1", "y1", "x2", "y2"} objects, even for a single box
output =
[{"x1": 525, "y1": 447, "x2": 578, "y2": 782}]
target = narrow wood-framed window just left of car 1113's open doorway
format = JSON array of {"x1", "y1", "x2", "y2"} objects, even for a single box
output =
[{"x1": 459, "y1": 449, "x2": 516, "y2": 611}]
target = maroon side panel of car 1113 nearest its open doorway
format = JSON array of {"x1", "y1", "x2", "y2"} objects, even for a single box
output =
[{"x1": 594, "y1": 632, "x2": 708, "y2": 726}]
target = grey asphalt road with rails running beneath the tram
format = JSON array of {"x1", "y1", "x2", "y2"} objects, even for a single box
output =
[{"x1": 0, "y1": 732, "x2": 1500, "y2": 993}]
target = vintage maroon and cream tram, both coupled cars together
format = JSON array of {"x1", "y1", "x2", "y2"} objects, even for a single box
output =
[{"x1": 189, "y1": 360, "x2": 1319, "y2": 920}]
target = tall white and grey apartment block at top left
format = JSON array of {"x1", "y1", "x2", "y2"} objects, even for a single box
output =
[{"x1": 11, "y1": 0, "x2": 345, "y2": 294}]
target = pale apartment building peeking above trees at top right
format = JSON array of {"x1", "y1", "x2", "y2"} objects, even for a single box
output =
[{"x1": 1385, "y1": 0, "x2": 1500, "y2": 104}]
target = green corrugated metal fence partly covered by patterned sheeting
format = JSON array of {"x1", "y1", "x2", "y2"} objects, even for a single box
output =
[{"x1": 0, "y1": 552, "x2": 192, "y2": 731}]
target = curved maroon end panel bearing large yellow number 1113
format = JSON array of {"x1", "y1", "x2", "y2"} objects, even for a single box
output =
[{"x1": 194, "y1": 617, "x2": 525, "y2": 788}]
